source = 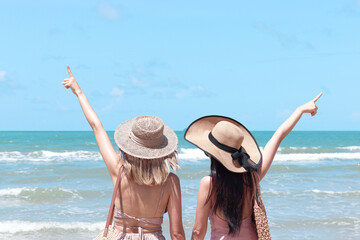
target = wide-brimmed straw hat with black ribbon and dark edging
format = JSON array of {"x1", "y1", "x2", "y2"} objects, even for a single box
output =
[{"x1": 184, "y1": 115, "x2": 262, "y2": 173}]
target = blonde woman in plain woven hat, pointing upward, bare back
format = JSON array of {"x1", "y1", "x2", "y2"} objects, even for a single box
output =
[{"x1": 62, "y1": 66, "x2": 185, "y2": 240}]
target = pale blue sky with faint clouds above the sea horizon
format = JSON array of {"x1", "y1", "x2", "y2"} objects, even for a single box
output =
[{"x1": 0, "y1": 0, "x2": 360, "y2": 130}]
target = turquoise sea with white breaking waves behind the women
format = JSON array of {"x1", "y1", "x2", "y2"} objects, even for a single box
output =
[{"x1": 0, "y1": 131, "x2": 360, "y2": 240}]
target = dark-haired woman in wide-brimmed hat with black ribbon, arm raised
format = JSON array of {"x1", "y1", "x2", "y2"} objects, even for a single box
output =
[{"x1": 185, "y1": 93, "x2": 322, "y2": 240}]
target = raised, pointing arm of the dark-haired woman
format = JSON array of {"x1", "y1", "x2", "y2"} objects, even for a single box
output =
[{"x1": 258, "y1": 93, "x2": 322, "y2": 180}]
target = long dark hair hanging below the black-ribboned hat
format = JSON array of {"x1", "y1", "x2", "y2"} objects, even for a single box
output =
[{"x1": 206, "y1": 157, "x2": 256, "y2": 234}]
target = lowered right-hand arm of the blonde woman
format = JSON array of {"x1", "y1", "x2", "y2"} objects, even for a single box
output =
[{"x1": 167, "y1": 173, "x2": 185, "y2": 240}]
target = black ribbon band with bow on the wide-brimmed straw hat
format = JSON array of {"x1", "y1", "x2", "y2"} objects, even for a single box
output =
[{"x1": 209, "y1": 132, "x2": 260, "y2": 171}]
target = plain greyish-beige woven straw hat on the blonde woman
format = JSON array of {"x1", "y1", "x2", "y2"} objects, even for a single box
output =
[{"x1": 114, "y1": 116, "x2": 178, "y2": 159}]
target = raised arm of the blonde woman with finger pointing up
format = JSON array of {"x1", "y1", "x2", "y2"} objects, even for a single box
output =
[{"x1": 62, "y1": 66, "x2": 120, "y2": 181}]
